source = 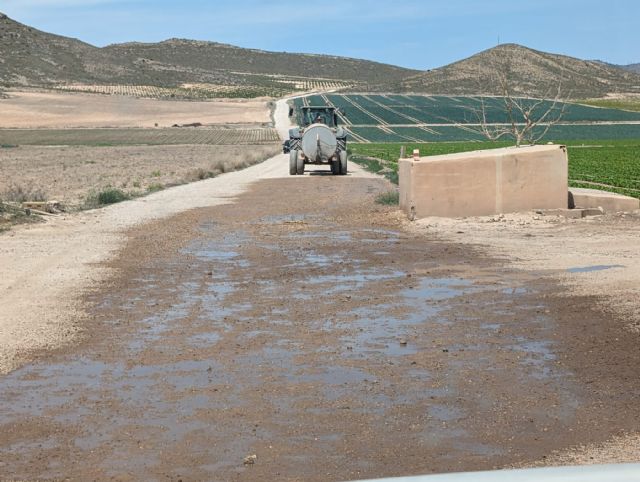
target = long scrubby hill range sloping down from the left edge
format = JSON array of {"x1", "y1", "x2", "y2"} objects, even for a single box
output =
[{"x1": 0, "y1": 14, "x2": 417, "y2": 93}]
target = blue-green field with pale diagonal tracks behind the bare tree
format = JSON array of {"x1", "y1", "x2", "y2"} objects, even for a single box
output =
[{"x1": 294, "y1": 94, "x2": 640, "y2": 143}]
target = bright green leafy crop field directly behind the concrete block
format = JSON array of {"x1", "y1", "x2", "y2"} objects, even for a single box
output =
[{"x1": 349, "y1": 139, "x2": 640, "y2": 198}]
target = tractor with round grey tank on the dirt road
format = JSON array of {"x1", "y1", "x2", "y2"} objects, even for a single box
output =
[{"x1": 282, "y1": 106, "x2": 347, "y2": 176}]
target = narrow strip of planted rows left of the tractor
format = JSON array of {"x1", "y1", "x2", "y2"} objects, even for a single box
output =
[{"x1": 0, "y1": 128, "x2": 280, "y2": 146}]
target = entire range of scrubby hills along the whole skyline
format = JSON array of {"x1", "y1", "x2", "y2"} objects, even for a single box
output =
[{"x1": 0, "y1": 14, "x2": 640, "y2": 98}]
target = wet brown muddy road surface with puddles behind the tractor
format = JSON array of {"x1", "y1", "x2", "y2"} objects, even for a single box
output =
[{"x1": 0, "y1": 176, "x2": 640, "y2": 480}]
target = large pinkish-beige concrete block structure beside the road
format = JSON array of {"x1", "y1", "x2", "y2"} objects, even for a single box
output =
[{"x1": 398, "y1": 145, "x2": 568, "y2": 218}]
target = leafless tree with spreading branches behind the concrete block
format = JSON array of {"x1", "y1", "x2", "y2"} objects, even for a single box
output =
[{"x1": 456, "y1": 54, "x2": 567, "y2": 147}]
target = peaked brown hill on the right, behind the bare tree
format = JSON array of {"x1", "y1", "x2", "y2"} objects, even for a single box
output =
[{"x1": 402, "y1": 44, "x2": 640, "y2": 98}]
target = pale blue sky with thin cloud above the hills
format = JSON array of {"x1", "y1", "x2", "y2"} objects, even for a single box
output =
[{"x1": 0, "y1": 0, "x2": 640, "y2": 69}]
